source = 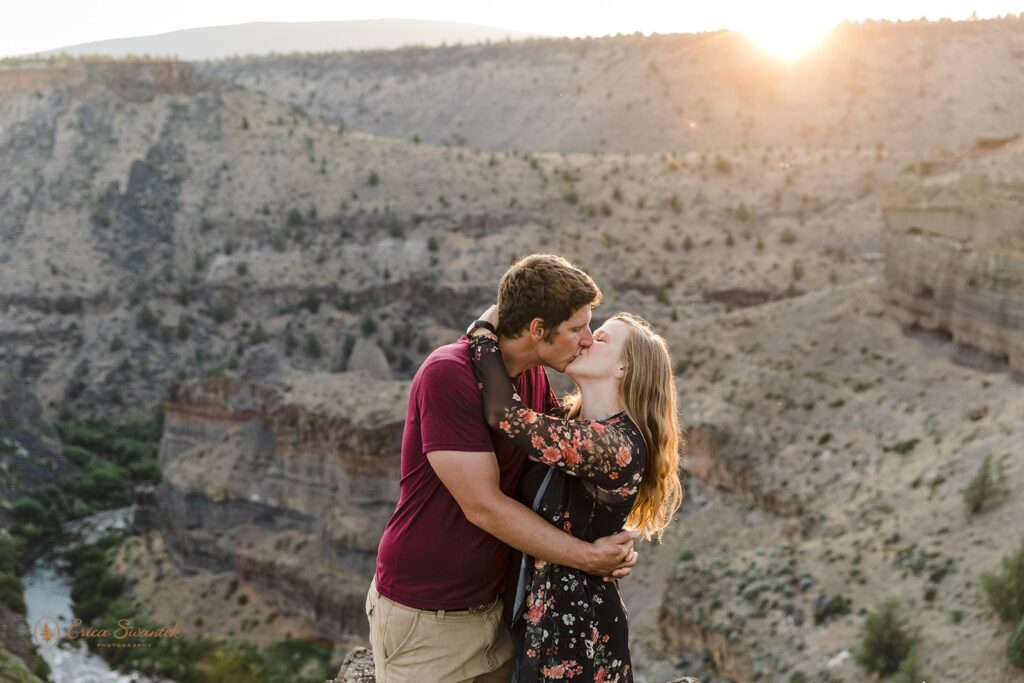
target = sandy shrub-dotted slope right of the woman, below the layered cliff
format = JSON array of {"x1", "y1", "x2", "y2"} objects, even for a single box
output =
[{"x1": 657, "y1": 276, "x2": 1024, "y2": 683}]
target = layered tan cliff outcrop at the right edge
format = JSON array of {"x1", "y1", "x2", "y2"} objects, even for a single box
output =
[{"x1": 882, "y1": 139, "x2": 1024, "y2": 373}]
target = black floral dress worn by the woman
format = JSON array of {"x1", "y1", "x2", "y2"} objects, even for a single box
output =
[{"x1": 470, "y1": 336, "x2": 646, "y2": 683}]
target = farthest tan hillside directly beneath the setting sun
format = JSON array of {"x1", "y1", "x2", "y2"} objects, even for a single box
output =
[{"x1": 202, "y1": 18, "x2": 1024, "y2": 154}]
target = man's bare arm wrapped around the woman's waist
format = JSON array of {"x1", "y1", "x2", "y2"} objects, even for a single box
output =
[{"x1": 427, "y1": 451, "x2": 636, "y2": 579}]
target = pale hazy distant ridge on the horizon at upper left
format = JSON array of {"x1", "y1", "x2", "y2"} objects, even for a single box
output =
[{"x1": 25, "y1": 18, "x2": 531, "y2": 59}]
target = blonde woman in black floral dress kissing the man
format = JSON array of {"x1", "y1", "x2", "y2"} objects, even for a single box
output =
[{"x1": 471, "y1": 313, "x2": 682, "y2": 682}]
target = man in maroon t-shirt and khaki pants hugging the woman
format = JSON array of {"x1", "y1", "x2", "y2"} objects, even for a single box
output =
[{"x1": 367, "y1": 254, "x2": 636, "y2": 683}]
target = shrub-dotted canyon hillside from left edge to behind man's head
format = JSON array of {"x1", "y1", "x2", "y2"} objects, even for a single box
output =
[{"x1": 0, "y1": 57, "x2": 902, "y2": 421}]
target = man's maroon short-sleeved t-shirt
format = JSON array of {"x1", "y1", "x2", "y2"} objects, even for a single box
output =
[{"x1": 376, "y1": 337, "x2": 555, "y2": 609}]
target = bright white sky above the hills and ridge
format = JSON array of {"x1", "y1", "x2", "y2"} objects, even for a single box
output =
[{"x1": 0, "y1": 0, "x2": 1024, "y2": 56}]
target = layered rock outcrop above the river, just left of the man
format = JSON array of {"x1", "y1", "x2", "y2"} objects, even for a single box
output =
[{"x1": 133, "y1": 346, "x2": 408, "y2": 642}]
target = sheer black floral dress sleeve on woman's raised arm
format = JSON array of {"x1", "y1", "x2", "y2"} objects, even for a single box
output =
[{"x1": 470, "y1": 336, "x2": 643, "y2": 500}]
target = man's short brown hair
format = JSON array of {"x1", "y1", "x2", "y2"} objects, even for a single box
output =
[{"x1": 498, "y1": 254, "x2": 601, "y2": 343}]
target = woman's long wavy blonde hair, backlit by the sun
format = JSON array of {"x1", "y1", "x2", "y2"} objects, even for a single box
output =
[{"x1": 565, "y1": 313, "x2": 683, "y2": 541}]
